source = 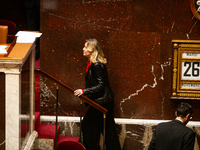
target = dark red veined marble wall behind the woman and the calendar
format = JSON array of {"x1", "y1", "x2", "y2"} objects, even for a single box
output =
[{"x1": 40, "y1": 0, "x2": 200, "y2": 121}]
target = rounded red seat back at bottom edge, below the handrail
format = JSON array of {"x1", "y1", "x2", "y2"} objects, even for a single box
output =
[{"x1": 57, "y1": 141, "x2": 85, "y2": 150}]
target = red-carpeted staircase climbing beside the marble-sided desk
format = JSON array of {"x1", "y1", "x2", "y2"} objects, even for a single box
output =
[{"x1": 33, "y1": 60, "x2": 85, "y2": 150}]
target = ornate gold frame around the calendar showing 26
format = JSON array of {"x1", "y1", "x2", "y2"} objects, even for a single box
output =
[{"x1": 171, "y1": 40, "x2": 200, "y2": 99}]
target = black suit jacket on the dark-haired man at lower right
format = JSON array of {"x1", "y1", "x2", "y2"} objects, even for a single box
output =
[{"x1": 149, "y1": 119, "x2": 195, "y2": 150}]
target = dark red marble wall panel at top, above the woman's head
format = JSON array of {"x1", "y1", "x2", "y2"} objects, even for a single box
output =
[{"x1": 41, "y1": 0, "x2": 132, "y2": 31}]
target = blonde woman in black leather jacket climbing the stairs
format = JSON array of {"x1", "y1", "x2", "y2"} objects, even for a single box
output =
[{"x1": 74, "y1": 39, "x2": 121, "y2": 150}]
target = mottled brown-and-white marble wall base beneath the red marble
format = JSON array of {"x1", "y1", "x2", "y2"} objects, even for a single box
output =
[{"x1": 33, "y1": 116, "x2": 200, "y2": 150}]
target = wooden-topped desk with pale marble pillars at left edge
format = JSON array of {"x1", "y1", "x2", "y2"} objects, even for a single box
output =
[{"x1": 0, "y1": 41, "x2": 35, "y2": 150}]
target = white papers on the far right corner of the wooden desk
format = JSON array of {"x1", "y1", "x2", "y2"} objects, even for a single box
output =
[{"x1": 15, "y1": 31, "x2": 42, "y2": 43}]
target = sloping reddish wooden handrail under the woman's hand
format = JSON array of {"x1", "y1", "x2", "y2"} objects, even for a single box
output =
[{"x1": 35, "y1": 69, "x2": 107, "y2": 114}]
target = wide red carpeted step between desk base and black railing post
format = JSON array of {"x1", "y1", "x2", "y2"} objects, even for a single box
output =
[{"x1": 36, "y1": 124, "x2": 60, "y2": 140}]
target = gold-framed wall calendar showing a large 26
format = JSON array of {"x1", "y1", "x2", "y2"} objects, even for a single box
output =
[{"x1": 171, "y1": 40, "x2": 200, "y2": 100}]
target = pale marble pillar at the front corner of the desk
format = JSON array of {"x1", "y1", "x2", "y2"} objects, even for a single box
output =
[{"x1": 5, "y1": 71, "x2": 21, "y2": 150}]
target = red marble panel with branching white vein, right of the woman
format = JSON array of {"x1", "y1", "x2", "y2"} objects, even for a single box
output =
[{"x1": 109, "y1": 32, "x2": 162, "y2": 118}]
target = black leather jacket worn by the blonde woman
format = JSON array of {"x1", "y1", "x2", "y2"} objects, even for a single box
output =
[{"x1": 83, "y1": 62, "x2": 114, "y2": 105}]
